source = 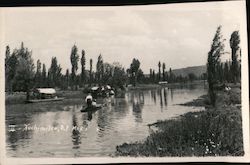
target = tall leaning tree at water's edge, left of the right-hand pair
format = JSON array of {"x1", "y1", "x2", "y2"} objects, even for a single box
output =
[{"x1": 207, "y1": 26, "x2": 224, "y2": 106}]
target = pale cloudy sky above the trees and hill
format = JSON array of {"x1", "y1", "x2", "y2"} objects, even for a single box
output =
[{"x1": 2, "y1": 1, "x2": 244, "y2": 73}]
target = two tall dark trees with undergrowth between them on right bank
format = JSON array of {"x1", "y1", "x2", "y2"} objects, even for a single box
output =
[{"x1": 207, "y1": 26, "x2": 241, "y2": 105}]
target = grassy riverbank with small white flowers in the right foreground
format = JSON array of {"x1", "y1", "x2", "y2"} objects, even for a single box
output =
[{"x1": 115, "y1": 85, "x2": 244, "y2": 157}]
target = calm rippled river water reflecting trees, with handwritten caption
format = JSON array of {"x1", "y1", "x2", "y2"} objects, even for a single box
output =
[{"x1": 6, "y1": 87, "x2": 206, "y2": 158}]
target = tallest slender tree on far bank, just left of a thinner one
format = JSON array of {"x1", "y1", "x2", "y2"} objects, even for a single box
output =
[{"x1": 70, "y1": 45, "x2": 79, "y2": 88}]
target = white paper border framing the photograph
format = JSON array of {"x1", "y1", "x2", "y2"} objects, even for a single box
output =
[{"x1": 0, "y1": 1, "x2": 250, "y2": 164}]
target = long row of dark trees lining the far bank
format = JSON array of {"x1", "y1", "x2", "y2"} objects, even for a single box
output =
[{"x1": 5, "y1": 43, "x2": 205, "y2": 92}]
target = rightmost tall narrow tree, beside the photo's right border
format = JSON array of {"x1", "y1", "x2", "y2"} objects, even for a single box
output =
[{"x1": 230, "y1": 31, "x2": 240, "y2": 83}]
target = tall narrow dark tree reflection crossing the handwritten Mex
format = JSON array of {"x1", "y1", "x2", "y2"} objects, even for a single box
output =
[{"x1": 71, "y1": 109, "x2": 81, "y2": 149}]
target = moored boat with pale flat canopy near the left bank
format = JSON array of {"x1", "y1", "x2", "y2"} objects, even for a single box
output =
[{"x1": 26, "y1": 88, "x2": 64, "y2": 103}]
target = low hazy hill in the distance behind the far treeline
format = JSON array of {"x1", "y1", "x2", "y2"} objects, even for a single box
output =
[{"x1": 172, "y1": 65, "x2": 207, "y2": 77}]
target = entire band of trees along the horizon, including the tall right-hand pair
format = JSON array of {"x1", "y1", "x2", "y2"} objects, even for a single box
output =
[{"x1": 5, "y1": 27, "x2": 241, "y2": 105}]
